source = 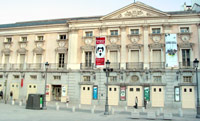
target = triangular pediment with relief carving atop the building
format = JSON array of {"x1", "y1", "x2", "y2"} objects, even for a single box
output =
[{"x1": 101, "y1": 2, "x2": 169, "y2": 20}]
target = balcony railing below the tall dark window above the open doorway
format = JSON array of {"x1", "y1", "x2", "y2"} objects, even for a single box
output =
[{"x1": 48, "y1": 63, "x2": 67, "y2": 70}]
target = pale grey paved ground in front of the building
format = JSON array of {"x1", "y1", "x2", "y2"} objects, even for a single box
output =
[{"x1": 0, "y1": 102, "x2": 200, "y2": 121}]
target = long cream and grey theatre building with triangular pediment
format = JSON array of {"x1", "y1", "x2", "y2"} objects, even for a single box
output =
[{"x1": 0, "y1": 2, "x2": 200, "y2": 108}]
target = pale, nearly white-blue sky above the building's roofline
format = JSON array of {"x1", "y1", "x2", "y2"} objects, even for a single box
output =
[{"x1": 0, "y1": 0, "x2": 191, "y2": 24}]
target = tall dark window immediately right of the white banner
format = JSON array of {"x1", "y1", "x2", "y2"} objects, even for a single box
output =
[{"x1": 182, "y1": 49, "x2": 190, "y2": 66}]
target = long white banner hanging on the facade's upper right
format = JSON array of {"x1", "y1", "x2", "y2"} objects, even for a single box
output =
[{"x1": 165, "y1": 34, "x2": 178, "y2": 67}]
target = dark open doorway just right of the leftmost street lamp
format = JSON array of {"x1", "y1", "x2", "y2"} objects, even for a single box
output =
[{"x1": 52, "y1": 85, "x2": 61, "y2": 101}]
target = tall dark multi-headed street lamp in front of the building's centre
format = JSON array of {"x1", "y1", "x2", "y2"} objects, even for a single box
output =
[{"x1": 103, "y1": 60, "x2": 113, "y2": 115}]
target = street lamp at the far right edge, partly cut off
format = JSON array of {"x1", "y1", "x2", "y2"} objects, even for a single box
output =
[{"x1": 193, "y1": 58, "x2": 200, "y2": 118}]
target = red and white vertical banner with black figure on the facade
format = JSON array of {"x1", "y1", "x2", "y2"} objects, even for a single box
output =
[{"x1": 95, "y1": 37, "x2": 106, "y2": 68}]
